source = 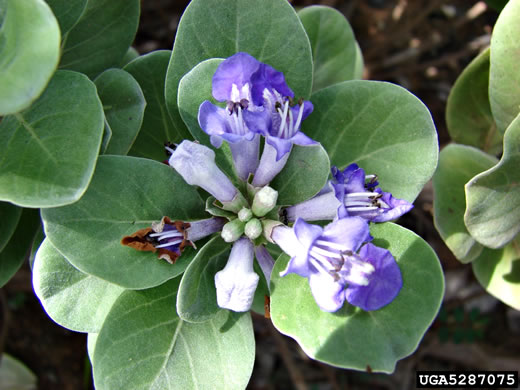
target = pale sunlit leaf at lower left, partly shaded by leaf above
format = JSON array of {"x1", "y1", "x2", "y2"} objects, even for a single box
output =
[{"x1": 33, "y1": 240, "x2": 124, "y2": 332}]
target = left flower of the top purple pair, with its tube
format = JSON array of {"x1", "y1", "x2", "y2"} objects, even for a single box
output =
[{"x1": 198, "y1": 53, "x2": 261, "y2": 180}]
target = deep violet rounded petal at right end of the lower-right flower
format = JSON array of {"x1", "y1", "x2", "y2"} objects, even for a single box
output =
[{"x1": 346, "y1": 244, "x2": 403, "y2": 311}]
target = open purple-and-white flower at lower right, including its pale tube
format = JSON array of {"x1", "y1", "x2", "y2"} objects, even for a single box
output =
[{"x1": 271, "y1": 217, "x2": 402, "y2": 312}]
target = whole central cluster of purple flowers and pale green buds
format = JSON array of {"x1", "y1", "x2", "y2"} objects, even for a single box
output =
[{"x1": 123, "y1": 53, "x2": 413, "y2": 312}]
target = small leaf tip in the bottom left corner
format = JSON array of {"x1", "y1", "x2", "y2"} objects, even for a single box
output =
[{"x1": 0, "y1": 353, "x2": 37, "y2": 390}]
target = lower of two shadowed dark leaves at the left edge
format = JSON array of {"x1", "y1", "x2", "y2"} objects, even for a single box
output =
[{"x1": 0, "y1": 209, "x2": 39, "y2": 287}]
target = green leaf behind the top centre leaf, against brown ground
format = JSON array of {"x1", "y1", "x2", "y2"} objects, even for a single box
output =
[{"x1": 298, "y1": 6, "x2": 363, "y2": 92}]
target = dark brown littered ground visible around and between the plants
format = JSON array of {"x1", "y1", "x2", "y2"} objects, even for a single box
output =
[{"x1": 0, "y1": 0, "x2": 520, "y2": 390}]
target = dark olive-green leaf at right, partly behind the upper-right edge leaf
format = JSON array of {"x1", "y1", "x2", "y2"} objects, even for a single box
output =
[{"x1": 446, "y1": 49, "x2": 502, "y2": 154}]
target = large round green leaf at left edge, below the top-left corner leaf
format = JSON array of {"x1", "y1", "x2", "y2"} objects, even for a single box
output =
[{"x1": 0, "y1": 71, "x2": 103, "y2": 207}]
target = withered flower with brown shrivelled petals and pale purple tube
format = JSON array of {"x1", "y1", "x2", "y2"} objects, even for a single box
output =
[{"x1": 121, "y1": 217, "x2": 225, "y2": 264}]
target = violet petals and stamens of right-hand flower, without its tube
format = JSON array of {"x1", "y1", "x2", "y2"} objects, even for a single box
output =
[{"x1": 332, "y1": 164, "x2": 413, "y2": 222}]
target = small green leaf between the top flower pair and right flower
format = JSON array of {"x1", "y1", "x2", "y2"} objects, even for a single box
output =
[{"x1": 270, "y1": 145, "x2": 330, "y2": 205}]
